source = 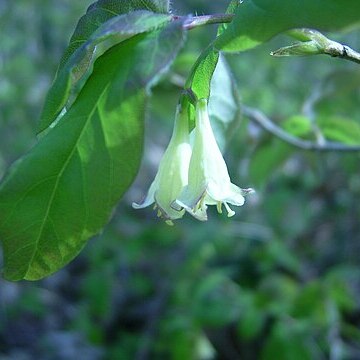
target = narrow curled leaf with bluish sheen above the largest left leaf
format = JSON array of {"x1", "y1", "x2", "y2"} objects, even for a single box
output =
[{"x1": 39, "y1": 8, "x2": 170, "y2": 132}]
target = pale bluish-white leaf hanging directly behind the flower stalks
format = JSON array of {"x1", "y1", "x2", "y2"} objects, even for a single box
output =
[{"x1": 209, "y1": 55, "x2": 240, "y2": 150}]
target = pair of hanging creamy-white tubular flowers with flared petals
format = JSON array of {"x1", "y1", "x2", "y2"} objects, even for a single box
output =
[{"x1": 133, "y1": 99, "x2": 253, "y2": 225}]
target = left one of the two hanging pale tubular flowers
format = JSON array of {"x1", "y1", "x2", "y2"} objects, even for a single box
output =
[{"x1": 132, "y1": 105, "x2": 191, "y2": 225}]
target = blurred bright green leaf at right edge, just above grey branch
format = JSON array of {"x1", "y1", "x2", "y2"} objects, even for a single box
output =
[{"x1": 317, "y1": 116, "x2": 360, "y2": 145}]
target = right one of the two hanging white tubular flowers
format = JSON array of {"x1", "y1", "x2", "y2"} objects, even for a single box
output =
[{"x1": 172, "y1": 99, "x2": 253, "y2": 221}]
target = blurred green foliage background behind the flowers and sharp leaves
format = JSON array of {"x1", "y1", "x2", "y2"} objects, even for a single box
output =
[{"x1": 0, "y1": 0, "x2": 360, "y2": 360}]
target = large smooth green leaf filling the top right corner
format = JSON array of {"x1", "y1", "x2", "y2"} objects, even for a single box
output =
[{"x1": 215, "y1": 0, "x2": 360, "y2": 52}]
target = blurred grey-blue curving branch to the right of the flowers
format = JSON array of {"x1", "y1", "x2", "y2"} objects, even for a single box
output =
[{"x1": 241, "y1": 106, "x2": 360, "y2": 152}]
